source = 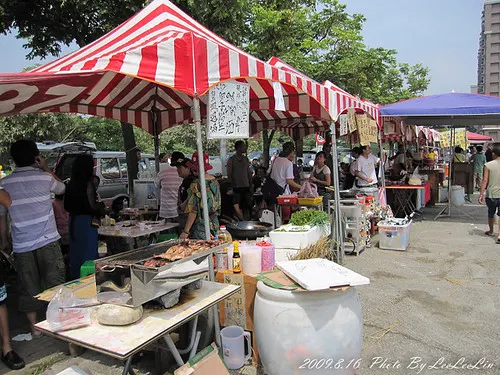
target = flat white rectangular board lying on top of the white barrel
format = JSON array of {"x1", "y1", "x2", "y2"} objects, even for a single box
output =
[{"x1": 277, "y1": 258, "x2": 370, "y2": 290}]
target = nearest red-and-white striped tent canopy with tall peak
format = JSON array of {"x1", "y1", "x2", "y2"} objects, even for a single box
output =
[{"x1": 0, "y1": 0, "x2": 337, "y2": 133}]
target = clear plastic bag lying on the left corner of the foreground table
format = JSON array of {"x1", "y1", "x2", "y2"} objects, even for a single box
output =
[{"x1": 47, "y1": 287, "x2": 92, "y2": 332}]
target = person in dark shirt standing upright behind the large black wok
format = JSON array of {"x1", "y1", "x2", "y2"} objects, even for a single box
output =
[{"x1": 227, "y1": 141, "x2": 253, "y2": 221}]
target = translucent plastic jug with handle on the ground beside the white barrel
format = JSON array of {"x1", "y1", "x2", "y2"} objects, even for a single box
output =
[{"x1": 220, "y1": 326, "x2": 252, "y2": 370}]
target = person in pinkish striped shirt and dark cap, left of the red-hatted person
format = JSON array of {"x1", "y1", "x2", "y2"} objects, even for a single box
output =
[{"x1": 158, "y1": 151, "x2": 184, "y2": 223}]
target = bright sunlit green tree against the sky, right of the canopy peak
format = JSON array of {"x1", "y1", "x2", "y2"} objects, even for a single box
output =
[{"x1": 247, "y1": 0, "x2": 430, "y2": 104}]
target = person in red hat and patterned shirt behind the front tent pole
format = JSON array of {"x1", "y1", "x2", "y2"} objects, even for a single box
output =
[{"x1": 180, "y1": 152, "x2": 221, "y2": 240}]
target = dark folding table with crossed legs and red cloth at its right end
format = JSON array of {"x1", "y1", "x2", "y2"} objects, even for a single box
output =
[{"x1": 386, "y1": 182, "x2": 431, "y2": 217}]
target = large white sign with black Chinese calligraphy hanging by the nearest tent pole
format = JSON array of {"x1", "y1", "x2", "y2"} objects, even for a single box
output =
[{"x1": 207, "y1": 81, "x2": 250, "y2": 139}]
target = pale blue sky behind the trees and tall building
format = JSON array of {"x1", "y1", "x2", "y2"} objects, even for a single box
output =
[{"x1": 0, "y1": 0, "x2": 483, "y2": 94}]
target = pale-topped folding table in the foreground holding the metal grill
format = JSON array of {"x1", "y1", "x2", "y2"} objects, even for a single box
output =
[{"x1": 35, "y1": 278, "x2": 240, "y2": 374}]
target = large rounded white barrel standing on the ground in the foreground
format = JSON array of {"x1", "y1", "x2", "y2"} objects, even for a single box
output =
[{"x1": 254, "y1": 281, "x2": 363, "y2": 375}]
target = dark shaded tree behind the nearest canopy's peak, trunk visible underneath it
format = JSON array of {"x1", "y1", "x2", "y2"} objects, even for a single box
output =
[{"x1": 0, "y1": 0, "x2": 254, "y2": 186}]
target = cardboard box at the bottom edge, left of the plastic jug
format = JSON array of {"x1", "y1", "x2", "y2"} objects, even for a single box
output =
[{"x1": 173, "y1": 343, "x2": 229, "y2": 375}]
